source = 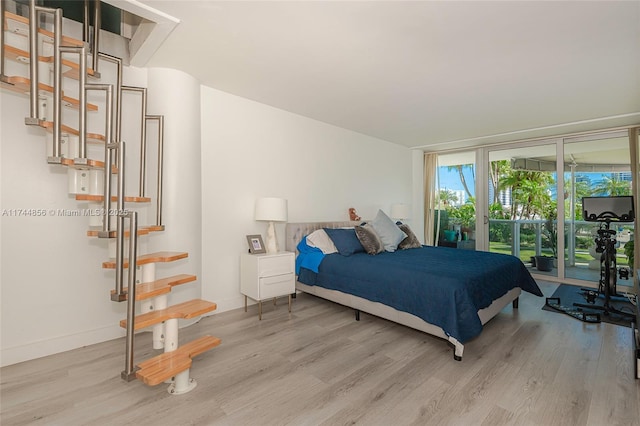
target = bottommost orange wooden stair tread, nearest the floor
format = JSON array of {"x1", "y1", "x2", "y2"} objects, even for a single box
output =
[{"x1": 136, "y1": 335, "x2": 221, "y2": 386}]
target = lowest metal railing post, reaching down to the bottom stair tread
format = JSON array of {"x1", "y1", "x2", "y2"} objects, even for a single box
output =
[{"x1": 122, "y1": 211, "x2": 138, "y2": 382}]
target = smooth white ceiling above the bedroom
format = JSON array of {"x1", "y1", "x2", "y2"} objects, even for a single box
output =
[{"x1": 132, "y1": 0, "x2": 640, "y2": 150}]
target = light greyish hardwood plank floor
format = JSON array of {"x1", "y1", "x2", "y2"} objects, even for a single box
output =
[{"x1": 0, "y1": 283, "x2": 640, "y2": 426}]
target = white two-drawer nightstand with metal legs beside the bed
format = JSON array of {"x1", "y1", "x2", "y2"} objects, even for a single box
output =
[{"x1": 240, "y1": 251, "x2": 296, "y2": 319}]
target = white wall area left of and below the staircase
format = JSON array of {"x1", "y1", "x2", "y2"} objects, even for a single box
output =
[{"x1": 0, "y1": 90, "x2": 126, "y2": 365}]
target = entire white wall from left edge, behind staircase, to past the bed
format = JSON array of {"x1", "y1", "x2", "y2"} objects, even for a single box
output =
[{"x1": 0, "y1": 68, "x2": 414, "y2": 365}]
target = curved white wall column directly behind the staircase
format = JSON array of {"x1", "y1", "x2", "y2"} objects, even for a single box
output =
[{"x1": 147, "y1": 68, "x2": 202, "y2": 306}]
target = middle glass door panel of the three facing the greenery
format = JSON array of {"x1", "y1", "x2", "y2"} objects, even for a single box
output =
[{"x1": 485, "y1": 140, "x2": 562, "y2": 277}]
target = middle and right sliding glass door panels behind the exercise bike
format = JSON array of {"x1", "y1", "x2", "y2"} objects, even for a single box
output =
[{"x1": 478, "y1": 130, "x2": 637, "y2": 286}]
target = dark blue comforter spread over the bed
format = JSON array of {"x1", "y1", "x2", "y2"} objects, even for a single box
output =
[{"x1": 298, "y1": 246, "x2": 542, "y2": 343}]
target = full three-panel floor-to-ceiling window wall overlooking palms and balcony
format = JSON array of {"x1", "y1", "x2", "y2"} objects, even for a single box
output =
[{"x1": 434, "y1": 129, "x2": 640, "y2": 287}]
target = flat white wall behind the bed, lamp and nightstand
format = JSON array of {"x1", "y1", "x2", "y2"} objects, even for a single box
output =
[{"x1": 201, "y1": 87, "x2": 413, "y2": 312}]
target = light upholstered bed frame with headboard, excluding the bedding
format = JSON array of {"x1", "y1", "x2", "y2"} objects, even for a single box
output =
[{"x1": 285, "y1": 222, "x2": 521, "y2": 361}]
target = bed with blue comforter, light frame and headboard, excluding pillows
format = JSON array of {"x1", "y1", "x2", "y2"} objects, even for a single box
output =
[{"x1": 286, "y1": 222, "x2": 542, "y2": 361}]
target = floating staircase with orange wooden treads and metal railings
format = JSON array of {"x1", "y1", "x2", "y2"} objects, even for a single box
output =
[{"x1": 0, "y1": 0, "x2": 220, "y2": 394}]
